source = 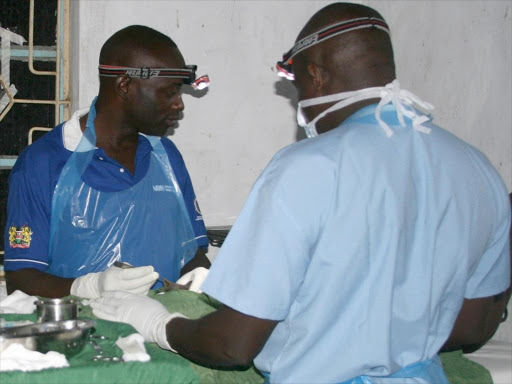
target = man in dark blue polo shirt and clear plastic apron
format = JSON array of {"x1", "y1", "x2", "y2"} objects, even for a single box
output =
[{"x1": 4, "y1": 25, "x2": 209, "y2": 297}]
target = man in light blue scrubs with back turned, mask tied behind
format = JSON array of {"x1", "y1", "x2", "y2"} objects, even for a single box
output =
[{"x1": 91, "y1": 3, "x2": 511, "y2": 384}]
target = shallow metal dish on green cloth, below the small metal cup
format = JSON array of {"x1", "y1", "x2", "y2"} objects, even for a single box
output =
[{"x1": 0, "y1": 320, "x2": 96, "y2": 357}]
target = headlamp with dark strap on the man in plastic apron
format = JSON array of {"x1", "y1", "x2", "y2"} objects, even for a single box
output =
[{"x1": 98, "y1": 65, "x2": 210, "y2": 90}]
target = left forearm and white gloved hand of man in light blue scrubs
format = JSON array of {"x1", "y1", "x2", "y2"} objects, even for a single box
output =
[{"x1": 90, "y1": 291, "x2": 278, "y2": 367}]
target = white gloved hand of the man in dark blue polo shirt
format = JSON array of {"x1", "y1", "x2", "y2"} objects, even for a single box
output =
[{"x1": 71, "y1": 266, "x2": 159, "y2": 299}]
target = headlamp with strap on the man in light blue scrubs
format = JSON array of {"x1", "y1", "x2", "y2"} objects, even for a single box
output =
[{"x1": 276, "y1": 17, "x2": 389, "y2": 80}]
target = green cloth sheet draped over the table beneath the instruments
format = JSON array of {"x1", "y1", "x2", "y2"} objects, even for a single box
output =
[{"x1": 0, "y1": 291, "x2": 492, "y2": 384}]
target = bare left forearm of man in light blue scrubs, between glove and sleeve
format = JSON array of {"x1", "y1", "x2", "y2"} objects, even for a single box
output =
[{"x1": 166, "y1": 306, "x2": 278, "y2": 366}]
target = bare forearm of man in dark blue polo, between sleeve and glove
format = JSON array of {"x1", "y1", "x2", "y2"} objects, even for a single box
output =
[{"x1": 5, "y1": 268, "x2": 74, "y2": 297}]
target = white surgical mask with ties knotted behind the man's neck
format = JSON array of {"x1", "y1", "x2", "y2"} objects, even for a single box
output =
[{"x1": 297, "y1": 79, "x2": 434, "y2": 138}]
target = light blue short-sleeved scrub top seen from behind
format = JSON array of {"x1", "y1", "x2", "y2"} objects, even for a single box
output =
[{"x1": 202, "y1": 105, "x2": 510, "y2": 383}]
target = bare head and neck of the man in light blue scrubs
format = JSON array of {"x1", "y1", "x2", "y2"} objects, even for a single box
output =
[{"x1": 291, "y1": 3, "x2": 395, "y2": 133}]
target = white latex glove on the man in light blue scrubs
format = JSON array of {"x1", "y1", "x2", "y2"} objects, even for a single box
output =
[{"x1": 90, "y1": 291, "x2": 186, "y2": 352}]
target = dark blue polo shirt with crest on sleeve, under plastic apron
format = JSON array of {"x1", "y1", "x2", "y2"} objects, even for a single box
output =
[{"x1": 4, "y1": 112, "x2": 208, "y2": 271}]
